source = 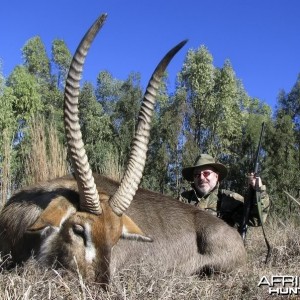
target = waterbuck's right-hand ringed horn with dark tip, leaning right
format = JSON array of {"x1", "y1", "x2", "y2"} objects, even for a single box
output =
[{"x1": 110, "y1": 40, "x2": 187, "y2": 215}]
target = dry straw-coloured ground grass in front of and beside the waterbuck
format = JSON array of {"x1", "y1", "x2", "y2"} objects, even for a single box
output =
[{"x1": 0, "y1": 218, "x2": 300, "y2": 300}]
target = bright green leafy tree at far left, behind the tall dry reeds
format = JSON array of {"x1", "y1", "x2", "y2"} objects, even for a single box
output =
[{"x1": 1, "y1": 66, "x2": 43, "y2": 189}]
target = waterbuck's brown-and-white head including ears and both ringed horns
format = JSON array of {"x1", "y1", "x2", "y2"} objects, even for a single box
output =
[{"x1": 22, "y1": 14, "x2": 186, "y2": 283}]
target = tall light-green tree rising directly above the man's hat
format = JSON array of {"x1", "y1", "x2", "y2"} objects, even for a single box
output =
[{"x1": 179, "y1": 46, "x2": 244, "y2": 171}]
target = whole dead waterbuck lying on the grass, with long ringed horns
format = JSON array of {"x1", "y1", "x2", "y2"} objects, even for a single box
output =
[{"x1": 0, "y1": 15, "x2": 246, "y2": 284}]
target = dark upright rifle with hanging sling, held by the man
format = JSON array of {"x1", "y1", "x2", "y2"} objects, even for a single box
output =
[{"x1": 240, "y1": 122, "x2": 271, "y2": 263}]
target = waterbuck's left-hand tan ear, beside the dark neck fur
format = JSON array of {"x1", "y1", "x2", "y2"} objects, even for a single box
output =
[{"x1": 27, "y1": 196, "x2": 76, "y2": 232}]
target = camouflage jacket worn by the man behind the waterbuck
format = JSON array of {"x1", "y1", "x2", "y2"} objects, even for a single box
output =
[{"x1": 180, "y1": 184, "x2": 270, "y2": 229}]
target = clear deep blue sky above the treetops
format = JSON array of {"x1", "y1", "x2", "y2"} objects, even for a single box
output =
[{"x1": 0, "y1": 0, "x2": 300, "y2": 107}]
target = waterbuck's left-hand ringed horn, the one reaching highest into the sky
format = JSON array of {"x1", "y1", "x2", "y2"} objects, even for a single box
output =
[{"x1": 64, "y1": 14, "x2": 107, "y2": 214}]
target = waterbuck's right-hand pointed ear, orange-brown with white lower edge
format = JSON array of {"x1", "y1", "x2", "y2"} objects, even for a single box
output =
[{"x1": 121, "y1": 214, "x2": 153, "y2": 242}]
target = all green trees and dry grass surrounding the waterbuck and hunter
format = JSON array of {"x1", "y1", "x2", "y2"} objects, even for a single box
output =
[{"x1": 0, "y1": 31, "x2": 300, "y2": 299}]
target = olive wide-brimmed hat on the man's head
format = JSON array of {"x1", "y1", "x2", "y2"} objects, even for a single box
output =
[{"x1": 182, "y1": 154, "x2": 228, "y2": 181}]
